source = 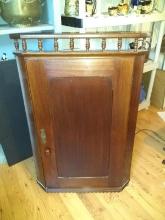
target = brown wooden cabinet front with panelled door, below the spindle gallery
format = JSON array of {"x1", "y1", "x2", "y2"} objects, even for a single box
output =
[{"x1": 23, "y1": 55, "x2": 143, "y2": 190}]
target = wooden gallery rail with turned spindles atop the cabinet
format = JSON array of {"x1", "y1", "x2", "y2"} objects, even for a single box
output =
[{"x1": 10, "y1": 32, "x2": 151, "y2": 53}]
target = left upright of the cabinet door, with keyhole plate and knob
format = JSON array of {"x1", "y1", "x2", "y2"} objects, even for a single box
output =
[{"x1": 23, "y1": 58, "x2": 58, "y2": 187}]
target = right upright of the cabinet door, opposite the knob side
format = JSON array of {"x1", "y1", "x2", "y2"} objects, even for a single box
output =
[{"x1": 109, "y1": 56, "x2": 135, "y2": 186}]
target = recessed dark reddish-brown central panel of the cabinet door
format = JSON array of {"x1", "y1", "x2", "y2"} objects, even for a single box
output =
[{"x1": 49, "y1": 77, "x2": 112, "y2": 177}]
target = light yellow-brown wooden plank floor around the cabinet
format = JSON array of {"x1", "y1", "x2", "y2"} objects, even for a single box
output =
[{"x1": 0, "y1": 108, "x2": 165, "y2": 220}]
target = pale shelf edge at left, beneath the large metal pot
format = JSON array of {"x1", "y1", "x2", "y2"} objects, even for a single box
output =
[{"x1": 0, "y1": 24, "x2": 54, "y2": 35}]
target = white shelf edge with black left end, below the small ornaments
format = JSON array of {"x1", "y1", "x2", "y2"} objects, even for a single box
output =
[{"x1": 61, "y1": 11, "x2": 165, "y2": 28}]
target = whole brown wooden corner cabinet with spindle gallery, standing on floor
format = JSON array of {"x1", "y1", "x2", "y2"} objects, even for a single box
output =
[{"x1": 13, "y1": 32, "x2": 149, "y2": 192}]
